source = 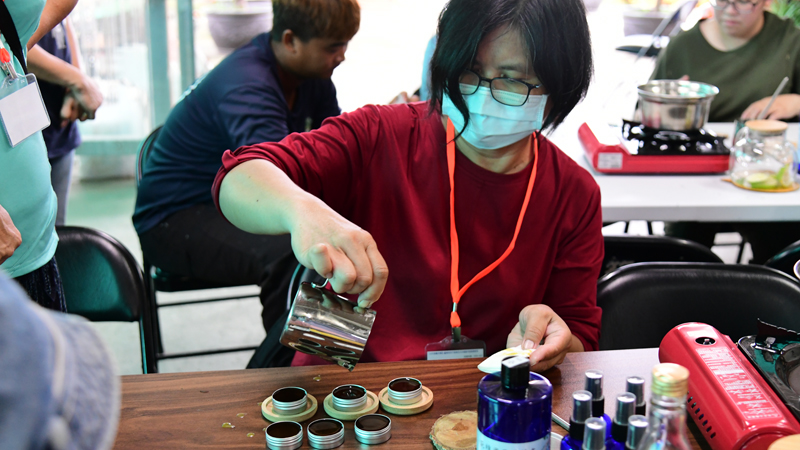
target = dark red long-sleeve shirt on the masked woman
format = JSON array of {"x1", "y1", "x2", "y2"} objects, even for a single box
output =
[{"x1": 213, "y1": 103, "x2": 603, "y2": 365}]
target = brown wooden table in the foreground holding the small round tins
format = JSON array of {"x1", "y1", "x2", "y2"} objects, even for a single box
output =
[{"x1": 115, "y1": 349, "x2": 702, "y2": 450}]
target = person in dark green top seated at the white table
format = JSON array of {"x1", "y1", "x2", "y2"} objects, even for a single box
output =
[{"x1": 650, "y1": 0, "x2": 800, "y2": 122}]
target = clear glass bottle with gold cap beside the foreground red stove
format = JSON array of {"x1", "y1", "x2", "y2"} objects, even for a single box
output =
[{"x1": 636, "y1": 363, "x2": 692, "y2": 450}]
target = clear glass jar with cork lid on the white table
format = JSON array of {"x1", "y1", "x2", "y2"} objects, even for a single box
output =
[{"x1": 730, "y1": 120, "x2": 797, "y2": 192}]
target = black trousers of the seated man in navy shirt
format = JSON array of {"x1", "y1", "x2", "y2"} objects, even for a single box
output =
[{"x1": 139, "y1": 204, "x2": 292, "y2": 329}]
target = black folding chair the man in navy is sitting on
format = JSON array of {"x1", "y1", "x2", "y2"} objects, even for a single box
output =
[{"x1": 136, "y1": 127, "x2": 256, "y2": 361}]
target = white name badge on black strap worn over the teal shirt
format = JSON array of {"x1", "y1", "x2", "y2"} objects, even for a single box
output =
[{"x1": 0, "y1": 1, "x2": 50, "y2": 147}]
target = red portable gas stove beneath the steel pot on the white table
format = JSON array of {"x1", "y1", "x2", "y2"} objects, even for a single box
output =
[{"x1": 578, "y1": 120, "x2": 730, "y2": 173}]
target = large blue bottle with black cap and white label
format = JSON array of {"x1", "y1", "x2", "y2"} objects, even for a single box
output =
[{"x1": 477, "y1": 356, "x2": 553, "y2": 450}]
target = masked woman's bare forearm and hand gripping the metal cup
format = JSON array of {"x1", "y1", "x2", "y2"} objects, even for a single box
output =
[{"x1": 219, "y1": 159, "x2": 389, "y2": 308}]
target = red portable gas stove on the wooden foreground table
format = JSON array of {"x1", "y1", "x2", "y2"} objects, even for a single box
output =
[{"x1": 659, "y1": 321, "x2": 800, "y2": 450}]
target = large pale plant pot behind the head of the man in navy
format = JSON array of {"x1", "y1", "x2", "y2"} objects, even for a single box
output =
[{"x1": 208, "y1": 0, "x2": 272, "y2": 53}]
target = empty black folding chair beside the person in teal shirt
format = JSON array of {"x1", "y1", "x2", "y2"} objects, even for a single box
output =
[{"x1": 56, "y1": 227, "x2": 157, "y2": 373}]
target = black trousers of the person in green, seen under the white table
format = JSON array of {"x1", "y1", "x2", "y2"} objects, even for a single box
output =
[{"x1": 664, "y1": 222, "x2": 800, "y2": 264}]
